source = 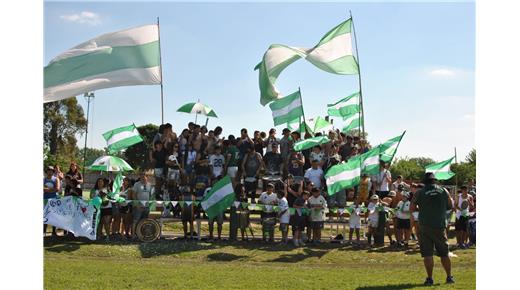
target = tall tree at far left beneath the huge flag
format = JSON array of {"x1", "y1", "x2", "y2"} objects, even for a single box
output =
[{"x1": 43, "y1": 98, "x2": 87, "y2": 167}]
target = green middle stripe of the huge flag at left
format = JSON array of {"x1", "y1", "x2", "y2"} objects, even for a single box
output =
[{"x1": 44, "y1": 41, "x2": 159, "y2": 88}]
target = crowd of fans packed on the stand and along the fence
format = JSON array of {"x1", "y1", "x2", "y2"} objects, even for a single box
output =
[{"x1": 44, "y1": 123, "x2": 476, "y2": 248}]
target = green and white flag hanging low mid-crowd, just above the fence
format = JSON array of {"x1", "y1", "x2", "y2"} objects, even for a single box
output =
[{"x1": 200, "y1": 175, "x2": 235, "y2": 219}]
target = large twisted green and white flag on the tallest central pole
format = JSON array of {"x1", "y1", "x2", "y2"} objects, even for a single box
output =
[{"x1": 255, "y1": 19, "x2": 359, "y2": 106}]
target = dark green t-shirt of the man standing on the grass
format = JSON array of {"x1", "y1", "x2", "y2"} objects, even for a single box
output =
[{"x1": 414, "y1": 184, "x2": 449, "y2": 229}]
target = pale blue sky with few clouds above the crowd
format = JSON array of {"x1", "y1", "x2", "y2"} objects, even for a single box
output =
[{"x1": 44, "y1": 2, "x2": 475, "y2": 161}]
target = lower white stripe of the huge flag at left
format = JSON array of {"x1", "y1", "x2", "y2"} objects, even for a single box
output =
[{"x1": 44, "y1": 66, "x2": 161, "y2": 103}]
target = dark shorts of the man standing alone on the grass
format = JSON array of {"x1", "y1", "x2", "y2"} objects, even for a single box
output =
[{"x1": 419, "y1": 225, "x2": 449, "y2": 257}]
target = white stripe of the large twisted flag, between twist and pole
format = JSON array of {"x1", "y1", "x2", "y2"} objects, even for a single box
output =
[{"x1": 307, "y1": 33, "x2": 352, "y2": 63}]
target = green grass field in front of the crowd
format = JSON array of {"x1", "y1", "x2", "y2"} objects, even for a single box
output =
[{"x1": 44, "y1": 239, "x2": 476, "y2": 289}]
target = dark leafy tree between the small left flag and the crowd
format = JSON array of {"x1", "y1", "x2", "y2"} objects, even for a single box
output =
[{"x1": 124, "y1": 124, "x2": 159, "y2": 169}]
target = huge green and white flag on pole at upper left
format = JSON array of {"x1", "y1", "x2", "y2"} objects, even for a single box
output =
[{"x1": 43, "y1": 25, "x2": 161, "y2": 102}]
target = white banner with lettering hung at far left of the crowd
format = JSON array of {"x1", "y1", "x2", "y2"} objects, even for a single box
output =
[{"x1": 43, "y1": 196, "x2": 99, "y2": 240}]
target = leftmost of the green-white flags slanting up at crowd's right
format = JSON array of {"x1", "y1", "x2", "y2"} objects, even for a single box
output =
[{"x1": 325, "y1": 156, "x2": 362, "y2": 195}]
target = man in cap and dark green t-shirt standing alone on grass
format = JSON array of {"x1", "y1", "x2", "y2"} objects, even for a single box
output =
[{"x1": 410, "y1": 172, "x2": 455, "y2": 286}]
